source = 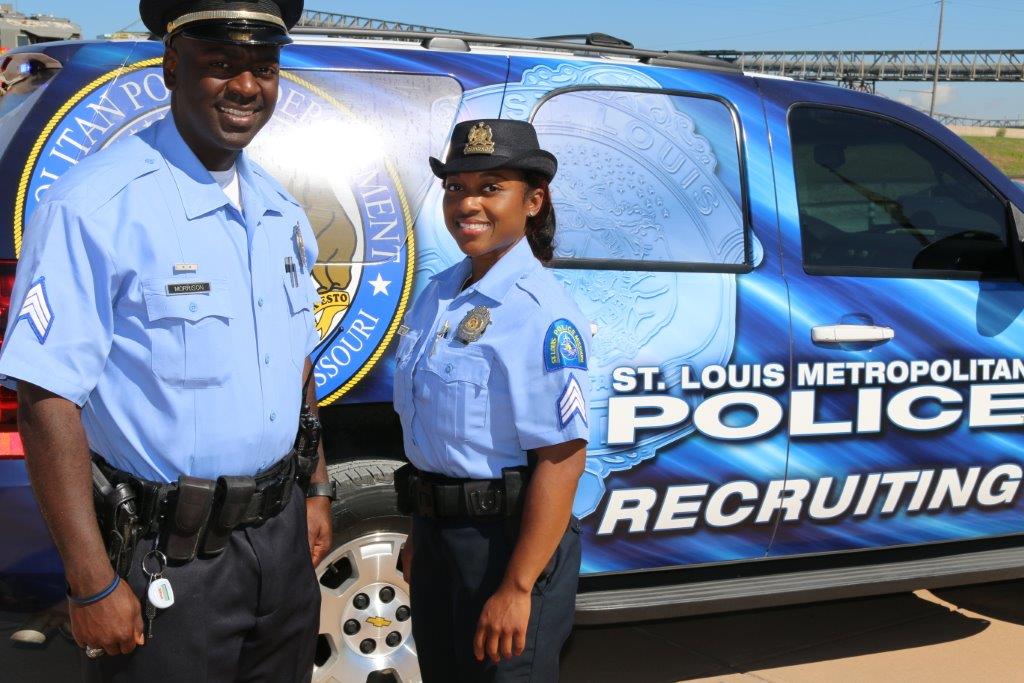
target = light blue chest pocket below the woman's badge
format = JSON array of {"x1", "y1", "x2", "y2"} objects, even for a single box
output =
[{"x1": 422, "y1": 346, "x2": 490, "y2": 441}]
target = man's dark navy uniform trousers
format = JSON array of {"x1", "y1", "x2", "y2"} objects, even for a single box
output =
[{"x1": 83, "y1": 486, "x2": 321, "y2": 683}]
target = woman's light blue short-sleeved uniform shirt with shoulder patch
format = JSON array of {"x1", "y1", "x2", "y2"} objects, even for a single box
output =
[{"x1": 394, "y1": 240, "x2": 590, "y2": 479}]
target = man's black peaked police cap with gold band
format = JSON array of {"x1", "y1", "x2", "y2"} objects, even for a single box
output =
[{"x1": 138, "y1": 0, "x2": 303, "y2": 45}]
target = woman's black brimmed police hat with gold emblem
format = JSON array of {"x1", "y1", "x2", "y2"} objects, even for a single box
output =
[{"x1": 430, "y1": 119, "x2": 558, "y2": 180}]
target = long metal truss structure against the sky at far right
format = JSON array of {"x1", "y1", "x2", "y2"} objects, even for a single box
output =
[{"x1": 697, "y1": 49, "x2": 1024, "y2": 84}]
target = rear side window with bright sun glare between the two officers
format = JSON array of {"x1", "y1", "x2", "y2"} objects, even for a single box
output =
[{"x1": 250, "y1": 71, "x2": 462, "y2": 266}]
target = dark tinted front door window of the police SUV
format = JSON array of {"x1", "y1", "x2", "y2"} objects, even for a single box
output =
[{"x1": 790, "y1": 106, "x2": 1015, "y2": 278}]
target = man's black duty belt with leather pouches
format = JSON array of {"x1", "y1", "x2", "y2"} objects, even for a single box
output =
[{"x1": 93, "y1": 453, "x2": 296, "y2": 562}]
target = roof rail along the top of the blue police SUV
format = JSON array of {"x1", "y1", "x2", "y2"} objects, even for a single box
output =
[{"x1": 292, "y1": 27, "x2": 742, "y2": 74}]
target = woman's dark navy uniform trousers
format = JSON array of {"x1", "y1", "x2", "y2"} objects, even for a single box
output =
[{"x1": 410, "y1": 516, "x2": 581, "y2": 683}]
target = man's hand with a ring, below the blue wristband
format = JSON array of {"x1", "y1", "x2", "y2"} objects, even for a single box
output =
[{"x1": 71, "y1": 582, "x2": 145, "y2": 655}]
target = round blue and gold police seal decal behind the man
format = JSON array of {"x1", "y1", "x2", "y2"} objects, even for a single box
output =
[{"x1": 13, "y1": 58, "x2": 415, "y2": 404}]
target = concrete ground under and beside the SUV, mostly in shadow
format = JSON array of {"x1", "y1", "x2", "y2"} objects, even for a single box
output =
[{"x1": 0, "y1": 581, "x2": 1024, "y2": 683}]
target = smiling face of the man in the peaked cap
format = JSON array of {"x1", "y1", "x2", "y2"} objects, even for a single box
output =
[{"x1": 164, "y1": 36, "x2": 281, "y2": 171}]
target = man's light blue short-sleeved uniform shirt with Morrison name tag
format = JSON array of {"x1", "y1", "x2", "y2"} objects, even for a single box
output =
[{"x1": 0, "y1": 115, "x2": 318, "y2": 481}]
